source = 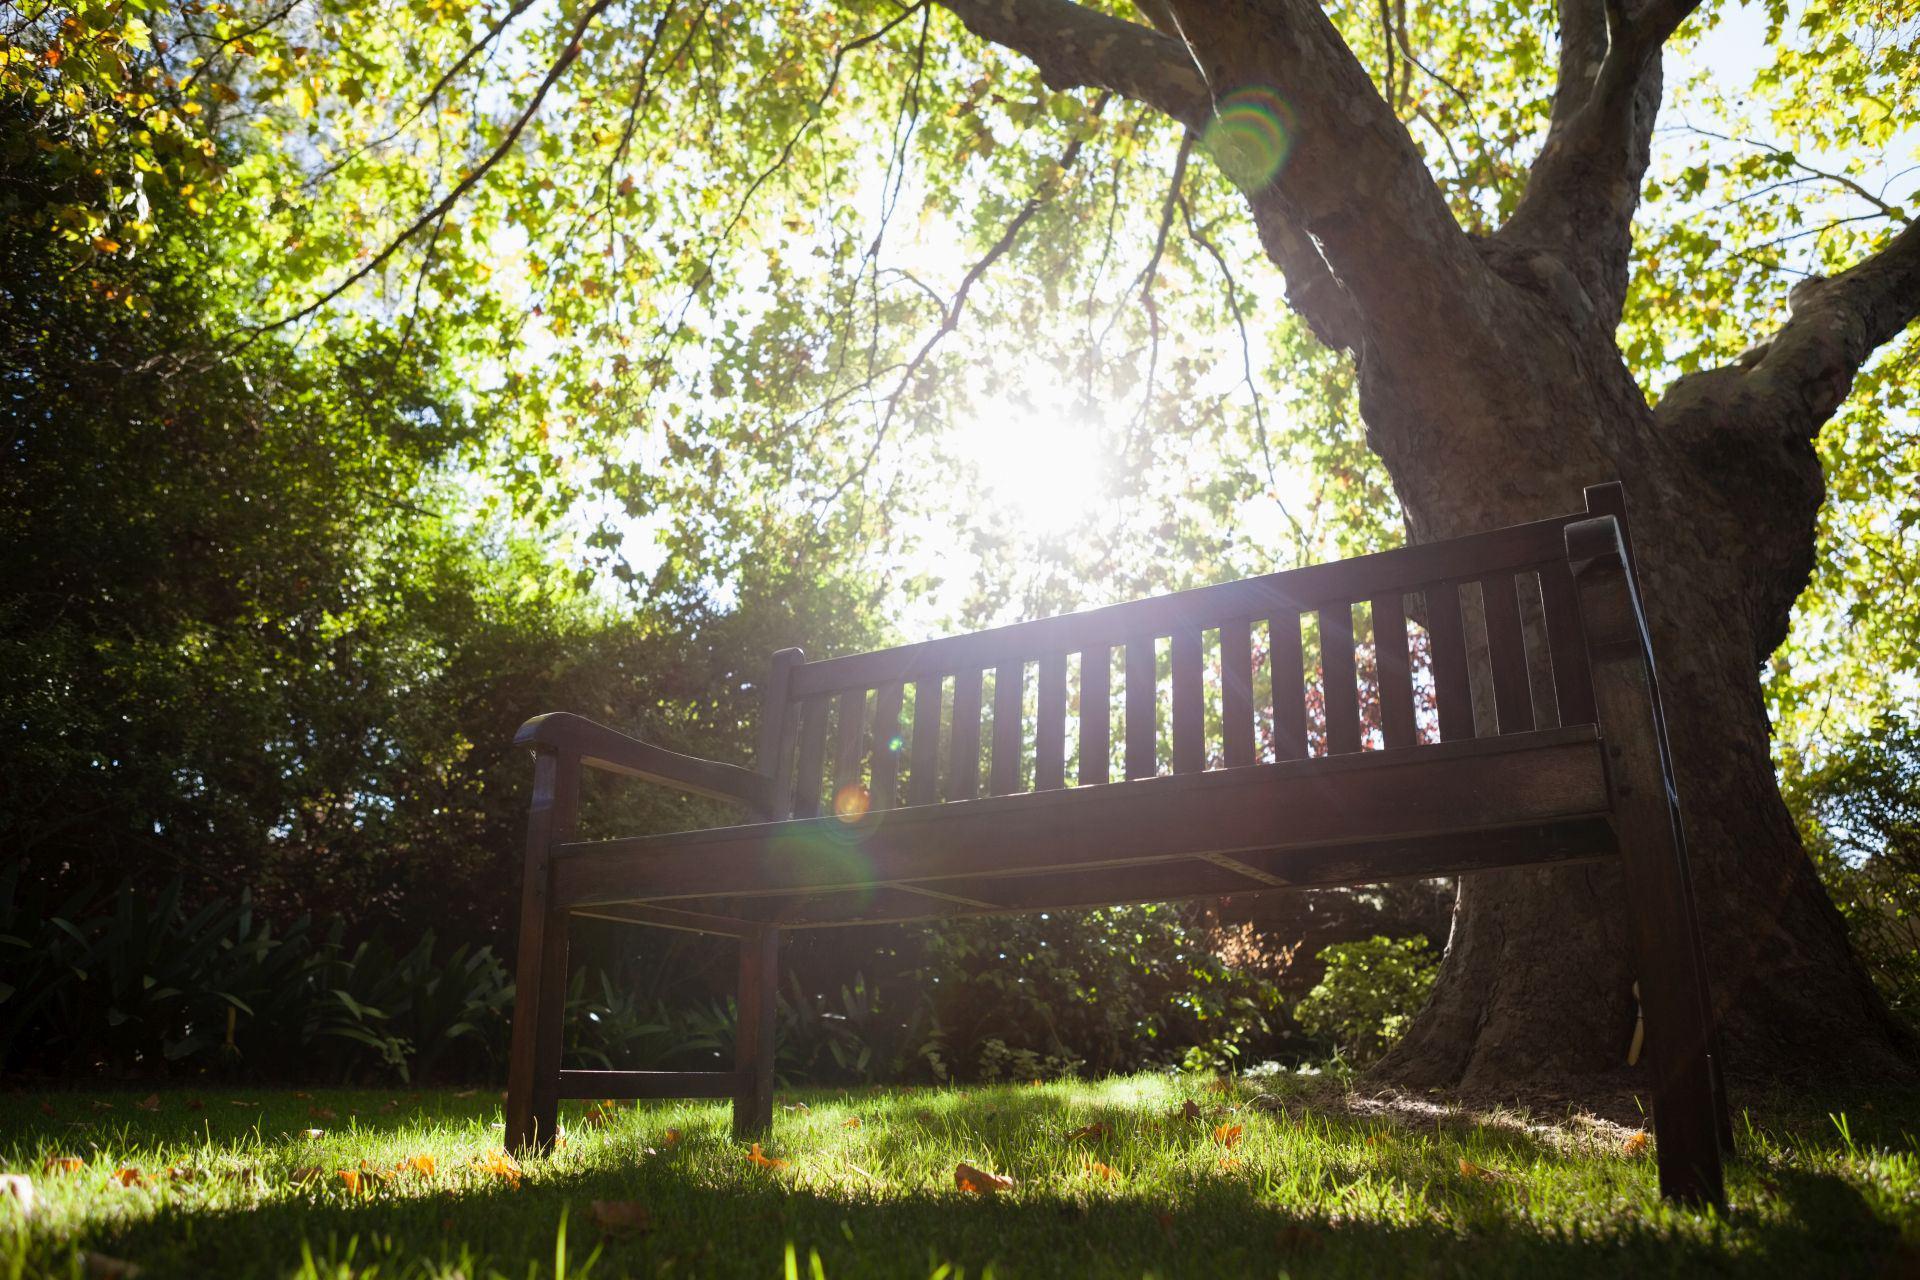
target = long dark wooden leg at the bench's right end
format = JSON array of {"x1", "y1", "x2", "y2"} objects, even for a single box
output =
[{"x1": 1567, "y1": 516, "x2": 1726, "y2": 1207}]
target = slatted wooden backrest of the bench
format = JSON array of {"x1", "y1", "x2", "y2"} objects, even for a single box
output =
[{"x1": 760, "y1": 484, "x2": 1624, "y2": 818}]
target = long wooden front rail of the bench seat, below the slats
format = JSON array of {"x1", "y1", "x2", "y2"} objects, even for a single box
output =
[{"x1": 553, "y1": 725, "x2": 1607, "y2": 906}]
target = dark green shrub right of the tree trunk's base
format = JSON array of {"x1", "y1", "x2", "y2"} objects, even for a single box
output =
[{"x1": 1786, "y1": 716, "x2": 1920, "y2": 1027}]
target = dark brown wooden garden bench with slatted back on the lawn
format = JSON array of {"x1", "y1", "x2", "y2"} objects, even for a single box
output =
[{"x1": 507, "y1": 486, "x2": 1728, "y2": 1203}]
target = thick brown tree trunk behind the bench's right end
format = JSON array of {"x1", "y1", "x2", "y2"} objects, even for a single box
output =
[{"x1": 1361, "y1": 276, "x2": 1912, "y2": 1096}]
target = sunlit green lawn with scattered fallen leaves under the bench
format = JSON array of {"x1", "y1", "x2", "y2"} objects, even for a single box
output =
[{"x1": 0, "y1": 1077, "x2": 1920, "y2": 1280}]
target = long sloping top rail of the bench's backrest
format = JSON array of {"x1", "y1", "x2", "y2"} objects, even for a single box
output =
[{"x1": 793, "y1": 514, "x2": 1582, "y2": 697}]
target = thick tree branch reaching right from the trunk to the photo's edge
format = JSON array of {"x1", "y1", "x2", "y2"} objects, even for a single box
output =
[{"x1": 1655, "y1": 223, "x2": 1920, "y2": 441}]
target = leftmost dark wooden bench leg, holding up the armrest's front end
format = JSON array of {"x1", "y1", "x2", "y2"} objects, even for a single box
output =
[{"x1": 507, "y1": 752, "x2": 580, "y2": 1153}]
